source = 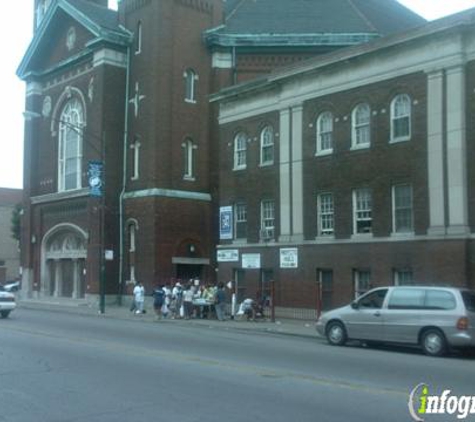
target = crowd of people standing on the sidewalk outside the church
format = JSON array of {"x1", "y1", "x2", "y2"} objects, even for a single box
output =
[{"x1": 130, "y1": 280, "x2": 226, "y2": 321}]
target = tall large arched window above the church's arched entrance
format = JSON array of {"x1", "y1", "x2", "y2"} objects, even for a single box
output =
[{"x1": 58, "y1": 99, "x2": 84, "y2": 192}]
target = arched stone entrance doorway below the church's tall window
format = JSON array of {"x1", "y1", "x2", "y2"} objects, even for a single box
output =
[{"x1": 41, "y1": 225, "x2": 87, "y2": 299}]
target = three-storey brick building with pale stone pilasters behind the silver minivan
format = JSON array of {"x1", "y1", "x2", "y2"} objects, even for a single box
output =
[{"x1": 216, "y1": 10, "x2": 475, "y2": 315}]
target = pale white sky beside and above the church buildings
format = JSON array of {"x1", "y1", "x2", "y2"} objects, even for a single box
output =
[{"x1": 0, "y1": 0, "x2": 475, "y2": 188}]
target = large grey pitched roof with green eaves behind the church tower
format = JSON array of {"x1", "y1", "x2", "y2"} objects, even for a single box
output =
[{"x1": 208, "y1": 0, "x2": 426, "y2": 44}]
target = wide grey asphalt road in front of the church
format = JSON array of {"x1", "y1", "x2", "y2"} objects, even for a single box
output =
[{"x1": 0, "y1": 309, "x2": 475, "y2": 422}]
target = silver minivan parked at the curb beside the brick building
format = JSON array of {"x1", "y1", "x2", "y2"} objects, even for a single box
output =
[{"x1": 316, "y1": 286, "x2": 475, "y2": 356}]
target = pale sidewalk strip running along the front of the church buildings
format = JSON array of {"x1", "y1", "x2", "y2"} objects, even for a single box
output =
[{"x1": 15, "y1": 298, "x2": 320, "y2": 339}]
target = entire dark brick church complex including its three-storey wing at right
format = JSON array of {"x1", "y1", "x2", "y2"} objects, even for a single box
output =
[{"x1": 18, "y1": 0, "x2": 475, "y2": 316}]
